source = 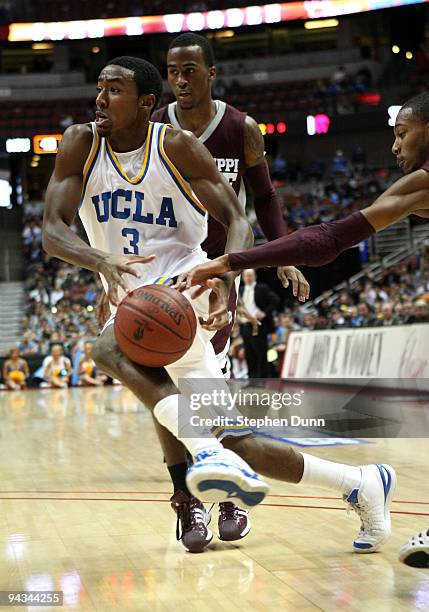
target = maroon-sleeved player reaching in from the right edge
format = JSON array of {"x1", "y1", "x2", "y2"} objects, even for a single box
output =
[{"x1": 176, "y1": 92, "x2": 429, "y2": 288}]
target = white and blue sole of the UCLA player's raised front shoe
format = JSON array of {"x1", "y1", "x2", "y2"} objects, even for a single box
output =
[{"x1": 186, "y1": 462, "x2": 269, "y2": 509}]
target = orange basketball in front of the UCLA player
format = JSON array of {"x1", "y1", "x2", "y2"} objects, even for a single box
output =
[{"x1": 115, "y1": 285, "x2": 197, "y2": 368}]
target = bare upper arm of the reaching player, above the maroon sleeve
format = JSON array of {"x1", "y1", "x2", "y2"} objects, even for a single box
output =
[{"x1": 362, "y1": 170, "x2": 429, "y2": 232}]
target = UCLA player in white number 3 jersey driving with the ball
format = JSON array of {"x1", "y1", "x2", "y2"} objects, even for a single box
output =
[{"x1": 43, "y1": 57, "x2": 396, "y2": 553}]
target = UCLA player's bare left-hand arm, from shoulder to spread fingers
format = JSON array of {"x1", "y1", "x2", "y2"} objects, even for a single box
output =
[{"x1": 43, "y1": 124, "x2": 153, "y2": 304}]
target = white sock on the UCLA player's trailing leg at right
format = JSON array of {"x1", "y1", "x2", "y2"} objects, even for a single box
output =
[{"x1": 300, "y1": 453, "x2": 361, "y2": 495}]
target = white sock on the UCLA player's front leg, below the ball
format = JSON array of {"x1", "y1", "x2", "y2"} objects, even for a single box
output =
[{"x1": 153, "y1": 395, "x2": 223, "y2": 457}]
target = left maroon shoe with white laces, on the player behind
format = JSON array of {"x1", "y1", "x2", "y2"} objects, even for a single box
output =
[{"x1": 170, "y1": 491, "x2": 213, "y2": 553}]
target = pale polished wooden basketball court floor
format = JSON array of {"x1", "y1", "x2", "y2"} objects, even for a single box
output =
[{"x1": 0, "y1": 387, "x2": 429, "y2": 612}]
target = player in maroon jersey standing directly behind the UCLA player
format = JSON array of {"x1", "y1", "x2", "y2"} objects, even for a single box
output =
[{"x1": 151, "y1": 33, "x2": 309, "y2": 548}]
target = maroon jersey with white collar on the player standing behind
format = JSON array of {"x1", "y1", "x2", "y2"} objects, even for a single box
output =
[{"x1": 151, "y1": 100, "x2": 246, "y2": 259}]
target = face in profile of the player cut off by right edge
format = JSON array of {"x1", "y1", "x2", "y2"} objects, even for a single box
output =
[{"x1": 392, "y1": 108, "x2": 429, "y2": 174}]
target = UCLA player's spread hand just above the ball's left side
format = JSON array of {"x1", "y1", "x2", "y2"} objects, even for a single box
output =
[{"x1": 98, "y1": 255, "x2": 155, "y2": 306}]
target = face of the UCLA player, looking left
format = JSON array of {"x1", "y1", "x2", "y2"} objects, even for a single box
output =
[{"x1": 95, "y1": 64, "x2": 140, "y2": 136}]
